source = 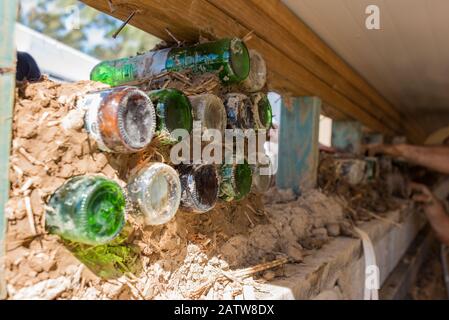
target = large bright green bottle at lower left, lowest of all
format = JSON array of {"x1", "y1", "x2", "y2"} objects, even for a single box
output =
[{"x1": 45, "y1": 176, "x2": 126, "y2": 245}]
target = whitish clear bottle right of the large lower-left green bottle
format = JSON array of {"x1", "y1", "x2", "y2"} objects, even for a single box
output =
[{"x1": 127, "y1": 162, "x2": 181, "y2": 225}]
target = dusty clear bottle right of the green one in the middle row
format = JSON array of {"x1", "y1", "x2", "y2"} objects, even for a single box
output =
[{"x1": 189, "y1": 93, "x2": 227, "y2": 133}]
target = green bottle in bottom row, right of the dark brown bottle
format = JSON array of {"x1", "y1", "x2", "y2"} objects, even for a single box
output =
[{"x1": 219, "y1": 160, "x2": 252, "y2": 202}]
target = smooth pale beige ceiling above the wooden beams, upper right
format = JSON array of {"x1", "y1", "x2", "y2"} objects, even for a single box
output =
[{"x1": 282, "y1": 0, "x2": 449, "y2": 133}]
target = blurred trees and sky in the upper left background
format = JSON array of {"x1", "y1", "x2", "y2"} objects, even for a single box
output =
[{"x1": 19, "y1": 0, "x2": 159, "y2": 60}]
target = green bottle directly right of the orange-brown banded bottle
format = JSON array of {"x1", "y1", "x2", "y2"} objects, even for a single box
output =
[{"x1": 148, "y1": 89, "x2": 193, "y2": 142}]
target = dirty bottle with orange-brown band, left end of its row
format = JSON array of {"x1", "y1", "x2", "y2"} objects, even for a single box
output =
[{"x1": 77, "y1": 87, "x2": 156, "y2": 153}]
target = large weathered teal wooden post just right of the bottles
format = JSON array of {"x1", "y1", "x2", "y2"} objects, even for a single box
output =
[{"x1": 276, "y1": 97, "x2": 321, "y2": 194}]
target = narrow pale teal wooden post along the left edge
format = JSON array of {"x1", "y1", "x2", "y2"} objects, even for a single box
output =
[{"x1": 0, "y1": 0, "x2": 17, "y2": 299}]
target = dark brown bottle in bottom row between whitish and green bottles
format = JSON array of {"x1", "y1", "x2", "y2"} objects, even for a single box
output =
[{"x1": 177, "y1": 164, "x2": 219, "y2": 213}]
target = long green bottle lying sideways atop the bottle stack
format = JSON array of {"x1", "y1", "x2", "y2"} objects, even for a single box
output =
[{"x1": 90, "y1": 38, "x2": 250, "y2": 86}]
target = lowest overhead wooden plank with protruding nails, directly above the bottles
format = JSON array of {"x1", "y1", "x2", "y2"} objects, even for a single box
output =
[{"x1": 79, "y1": 0, "x2": 399, "y2": 134}]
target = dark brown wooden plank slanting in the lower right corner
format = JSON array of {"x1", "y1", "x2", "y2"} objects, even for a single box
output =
[{"x1": 379, "y1": 227, "x2": 436, "y2": 300}]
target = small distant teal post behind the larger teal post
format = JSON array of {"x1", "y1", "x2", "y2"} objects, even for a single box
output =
[{"x1": 332, "y1": 121, "x2": 362, "y2": 154}]
